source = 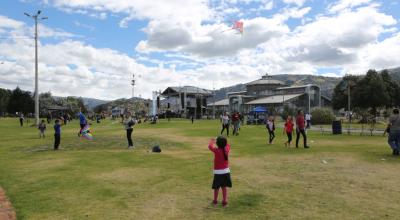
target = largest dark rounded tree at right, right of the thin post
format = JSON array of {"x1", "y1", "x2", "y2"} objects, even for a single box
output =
[{"x1": 353, "y1": 70, "x2": 389, "y2": 115}]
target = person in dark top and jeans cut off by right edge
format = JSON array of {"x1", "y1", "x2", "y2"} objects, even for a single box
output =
[{"x1": 388, "y1": 108, "x2": 400, "y2": 156}]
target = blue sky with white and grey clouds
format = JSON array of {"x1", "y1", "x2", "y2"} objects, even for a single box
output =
[{"x1": 0, "y1": 0, "x2": 400, "y2": 99}]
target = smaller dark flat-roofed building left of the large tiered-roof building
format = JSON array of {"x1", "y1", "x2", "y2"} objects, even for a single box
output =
[{"x1": 158, "y1": 86, "x2": 213, "y2": 118}]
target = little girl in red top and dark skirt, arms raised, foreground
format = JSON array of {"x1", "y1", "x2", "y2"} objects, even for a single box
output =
[{"x1": 208, "y1": 136, "x2": 232, "y2": 207}]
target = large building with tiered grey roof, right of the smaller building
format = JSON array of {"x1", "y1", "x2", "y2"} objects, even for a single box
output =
[{"x1": 208, "y1": 74, "x2": 330, "y2": 114}]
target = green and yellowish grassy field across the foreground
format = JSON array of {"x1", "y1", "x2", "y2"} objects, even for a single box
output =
[{"x1": 0, "y1": 118, "x2": 400, "y2": 220}]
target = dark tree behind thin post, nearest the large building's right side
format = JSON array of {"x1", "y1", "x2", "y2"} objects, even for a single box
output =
[{"x1": 332, "y1": 75, "x2": 360, "y2": 110}]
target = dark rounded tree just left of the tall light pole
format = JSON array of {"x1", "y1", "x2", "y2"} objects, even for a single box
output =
[{"x1": 7, "y1": 87, "x2": 35, "y2": 114}]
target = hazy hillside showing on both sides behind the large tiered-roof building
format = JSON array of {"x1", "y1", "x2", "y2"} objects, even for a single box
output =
[{"x1": 215, "y1": 74, "x2": 340, "y2": 101}]
